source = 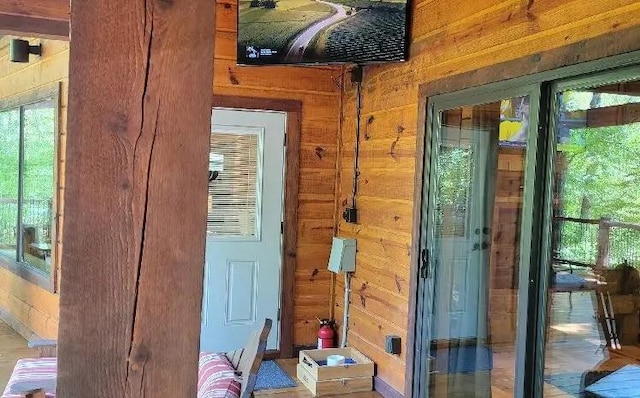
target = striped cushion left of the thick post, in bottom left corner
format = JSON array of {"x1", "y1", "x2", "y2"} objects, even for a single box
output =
[{"x1": 2, "y1": 358, "x2": 57, "y2": 398}]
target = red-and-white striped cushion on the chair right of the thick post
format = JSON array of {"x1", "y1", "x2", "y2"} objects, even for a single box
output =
[{"x1": 198, "y1": 352, "x2": 240, "y2": 398}]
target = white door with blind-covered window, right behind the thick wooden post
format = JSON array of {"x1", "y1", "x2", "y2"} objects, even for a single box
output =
[{"x1": 200, "y1": 109, "x2": 286, "y2": 352}]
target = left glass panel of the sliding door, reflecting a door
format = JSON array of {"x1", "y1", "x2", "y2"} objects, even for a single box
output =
[{"x1": 418, "y1": 91, "x2": 533, "y2": 397}]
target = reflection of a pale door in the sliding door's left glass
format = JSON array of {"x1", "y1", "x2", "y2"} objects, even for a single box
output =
[{"x1": 433, "y1": 126, "x2": 498, "y2": 340}]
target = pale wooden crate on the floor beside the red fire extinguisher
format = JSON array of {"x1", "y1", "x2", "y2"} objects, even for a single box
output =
[{"x1": 297, "y1": 347, "x2": 373, "y2": 396}]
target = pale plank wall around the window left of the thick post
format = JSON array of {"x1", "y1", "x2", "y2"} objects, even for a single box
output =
[{"x1": 0, "y1": 36, "x2": 69, "y2": 338}]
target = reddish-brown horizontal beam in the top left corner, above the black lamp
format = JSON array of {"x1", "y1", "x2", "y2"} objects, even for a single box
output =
[{"x1": 0, "y1": 0, "x2": 69, "y2": 40}]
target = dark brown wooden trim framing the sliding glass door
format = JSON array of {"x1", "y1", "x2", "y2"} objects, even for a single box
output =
[{"x1": 404, "y1": 26, "x2": 640, "y2": 398}]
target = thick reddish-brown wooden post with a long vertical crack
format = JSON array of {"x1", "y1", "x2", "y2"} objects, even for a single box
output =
[{"x1": 58, "y1": 0, "x2": 215, "y2": 398}]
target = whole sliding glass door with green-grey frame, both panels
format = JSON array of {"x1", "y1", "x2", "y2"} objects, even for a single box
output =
[{"x1": 413, "y1": 60, "x2": 640, "y2": 398}]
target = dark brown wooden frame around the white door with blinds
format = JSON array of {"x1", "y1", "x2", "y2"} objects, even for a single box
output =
[{"x1": 212, "y1": 95, "x2": 302, "y2": 358}]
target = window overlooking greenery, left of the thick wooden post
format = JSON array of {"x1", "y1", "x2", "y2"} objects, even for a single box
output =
[{"x1": 0, "y1": 85, "x2": 59, "y2": 290}]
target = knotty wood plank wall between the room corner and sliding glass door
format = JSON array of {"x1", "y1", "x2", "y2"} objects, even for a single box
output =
[{"x1": 335, "y1": 0, "x2": 640, "y2": 391}]
